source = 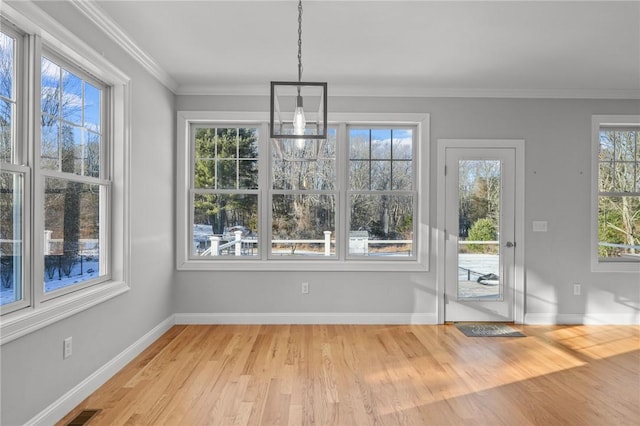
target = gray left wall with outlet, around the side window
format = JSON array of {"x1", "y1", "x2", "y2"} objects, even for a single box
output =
[{"x1": 0, "y1": 3, "x2": 175, "y2": 426}]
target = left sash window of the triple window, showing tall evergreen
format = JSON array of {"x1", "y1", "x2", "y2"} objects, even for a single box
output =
[{"x1": 190, "y1": 125, "x2": 259, "y2": 257}]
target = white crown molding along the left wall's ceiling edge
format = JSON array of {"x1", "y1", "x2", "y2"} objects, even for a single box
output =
[{"x1": 68, "y1": 0, "x2": 178, "y2": 93}]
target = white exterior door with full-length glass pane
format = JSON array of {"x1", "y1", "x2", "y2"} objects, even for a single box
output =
[{"x1": 444, "y1": 147, "x2": 516, "y2": 322}]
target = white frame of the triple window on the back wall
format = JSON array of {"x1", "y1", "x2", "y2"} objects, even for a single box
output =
[{"x1": 176, "y1": 111, "x2": 430, "y2": 271}]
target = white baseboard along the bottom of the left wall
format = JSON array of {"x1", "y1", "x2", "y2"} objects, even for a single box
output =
[{"x1": 26, "y1": 315, "x2": 175, "y2": 425}]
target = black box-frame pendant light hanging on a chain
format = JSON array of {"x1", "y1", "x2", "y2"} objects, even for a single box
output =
[{"x1": 269, "y1": 0, "x2": 327, "y2": 140}]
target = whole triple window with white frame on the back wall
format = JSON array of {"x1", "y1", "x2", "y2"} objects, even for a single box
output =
[{"x1": 177, "y1": 112, "x2": 428, "y2": 270}]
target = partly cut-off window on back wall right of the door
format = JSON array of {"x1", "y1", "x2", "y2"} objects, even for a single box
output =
[{"x1": 591, "y1": 116, "x2": 640, "y2": 271}]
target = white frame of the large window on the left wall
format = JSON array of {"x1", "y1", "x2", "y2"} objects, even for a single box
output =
[{"x1": 0, "y1": 2, "x2": 130, "y2": 344}]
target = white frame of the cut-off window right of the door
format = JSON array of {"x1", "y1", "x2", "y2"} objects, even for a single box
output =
[{"x1": 589, "y1": 115, "x2": 640, "y2": 273}]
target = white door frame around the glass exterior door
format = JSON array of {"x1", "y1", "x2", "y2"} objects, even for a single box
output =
[{"x1": 436, "y1": 139, "x2": 525, "y2": 324}]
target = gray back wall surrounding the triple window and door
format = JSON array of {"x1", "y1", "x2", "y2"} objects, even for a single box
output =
[{"x1": 174, "y1": 96, "x2": 640, "y2": 320}]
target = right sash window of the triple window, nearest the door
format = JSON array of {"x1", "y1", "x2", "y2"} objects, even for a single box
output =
[{"x1": 348, "y1": 127, "x2": 418, "y2": 258}]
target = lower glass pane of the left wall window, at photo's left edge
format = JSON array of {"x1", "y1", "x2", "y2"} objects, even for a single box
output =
[{"x1": 0, "y1": 172, "x2": 23, "y2": 305}]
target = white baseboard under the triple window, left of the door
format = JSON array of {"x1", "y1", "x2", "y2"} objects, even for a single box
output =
[{"x1": 175, "y1": 313, "x2": 438, "y2": 325}]
